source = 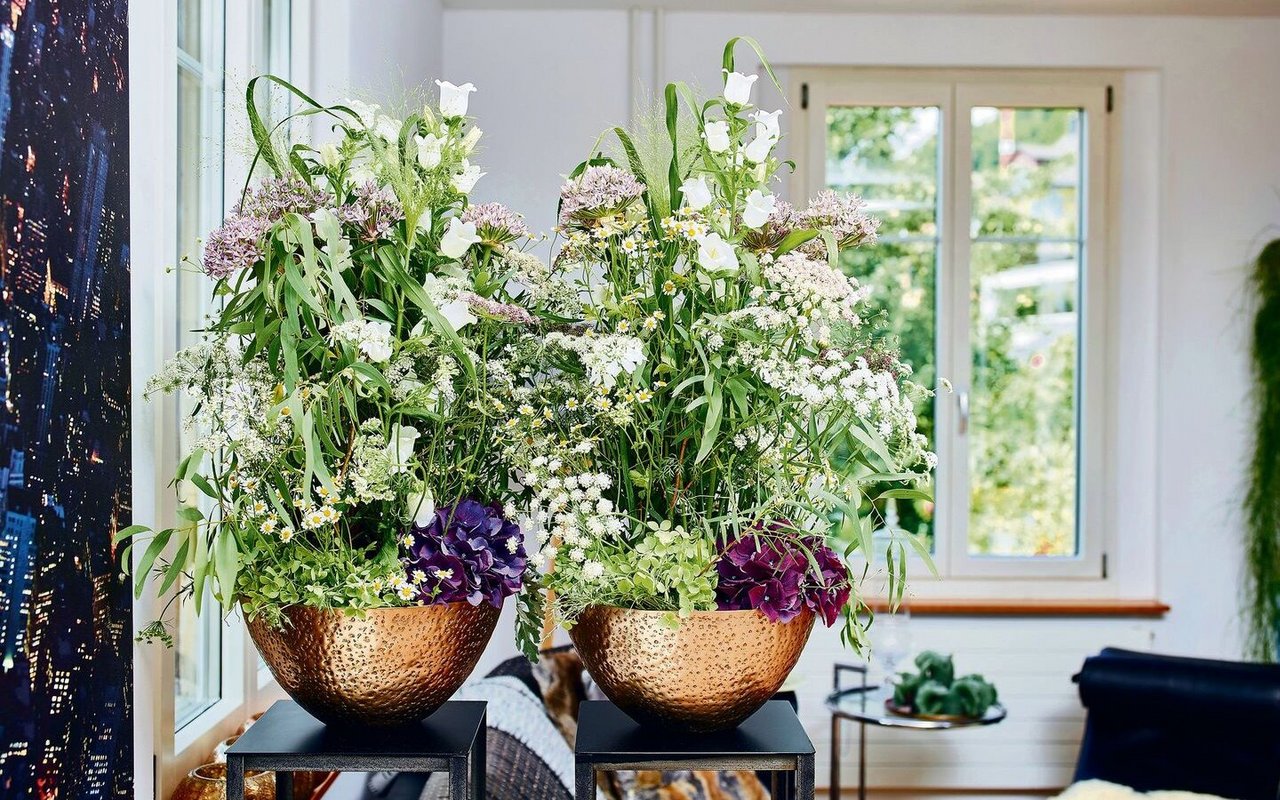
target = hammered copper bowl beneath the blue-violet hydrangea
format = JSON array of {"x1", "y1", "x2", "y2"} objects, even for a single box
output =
[{"x1": 248, "y1": 603, "x2": 499, "y2": 727}]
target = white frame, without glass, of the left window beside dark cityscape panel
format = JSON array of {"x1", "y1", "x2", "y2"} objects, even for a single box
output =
[{"x1": 129, "y1": 0, "x2": 312, "y2": 800}]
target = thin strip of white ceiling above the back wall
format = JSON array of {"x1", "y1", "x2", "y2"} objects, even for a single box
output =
[{"x1": 444, "y1": 0, "x2": 1280, "y2": 17}]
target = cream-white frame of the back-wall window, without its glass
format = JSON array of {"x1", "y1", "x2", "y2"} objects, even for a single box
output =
[{"x1": 787, "y1": 67, "x2": 1121, "y2": 588}]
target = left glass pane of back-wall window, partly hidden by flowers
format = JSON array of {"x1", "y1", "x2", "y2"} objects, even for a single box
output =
[{"x1": 826, "y1": 106, "x2": 940, "y2": 545}]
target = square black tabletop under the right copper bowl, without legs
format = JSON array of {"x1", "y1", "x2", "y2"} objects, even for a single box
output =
[{"x1": 578, "y1": 700, "x2": 813, "y2": 762}]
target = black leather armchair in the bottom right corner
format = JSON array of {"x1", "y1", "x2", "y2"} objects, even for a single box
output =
[{"x1": 1074, "y1": 648, "x2": 1280, "y2": 800}]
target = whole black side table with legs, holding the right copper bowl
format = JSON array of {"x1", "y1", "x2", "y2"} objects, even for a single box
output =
[{"x1": 576, "y1": 700, "x2": 814, "y2": 800}]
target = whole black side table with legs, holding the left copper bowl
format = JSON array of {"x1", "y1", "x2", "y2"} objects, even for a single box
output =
[{"x1": 227, "y1": 700, "x2": 485, "y2": 800}]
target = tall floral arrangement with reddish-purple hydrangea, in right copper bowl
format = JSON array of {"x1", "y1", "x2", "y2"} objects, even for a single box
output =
[{"x1": 504, "y1": 40, "x2": 934, "y2": 652}]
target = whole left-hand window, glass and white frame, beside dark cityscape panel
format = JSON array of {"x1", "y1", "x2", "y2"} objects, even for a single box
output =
[{"x1": 131, "y1": 0, "x2": 302, "y2": 796}]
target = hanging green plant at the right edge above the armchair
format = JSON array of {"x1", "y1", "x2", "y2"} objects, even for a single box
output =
[{"x1": 1244, "y1": 239, "x2": 1280, "y2": 662}]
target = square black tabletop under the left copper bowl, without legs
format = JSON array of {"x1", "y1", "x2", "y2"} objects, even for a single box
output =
[{"x1": 227, "y1": 700, "x2": 485, "y2": 758}]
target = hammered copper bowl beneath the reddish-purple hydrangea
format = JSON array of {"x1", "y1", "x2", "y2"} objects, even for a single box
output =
[{"x1": 570, "y1": 605, "x2": 814, "y2": 732}]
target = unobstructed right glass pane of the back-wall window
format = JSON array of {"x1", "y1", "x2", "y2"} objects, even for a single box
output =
[{"x1": 968, "y1": 108, "x2": 1083, "y2": 557}]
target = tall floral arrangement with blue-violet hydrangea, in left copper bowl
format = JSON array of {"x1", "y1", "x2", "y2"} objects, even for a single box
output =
[{"x1": 122, "y1": 76, "x2": 547, "y2": 637}]
